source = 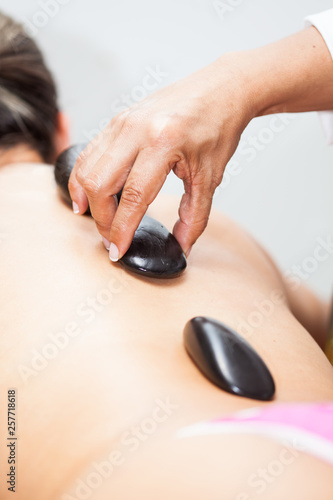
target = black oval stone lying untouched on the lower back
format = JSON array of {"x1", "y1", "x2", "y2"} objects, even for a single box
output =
[{"x1": 184, "y1": 316, "x2": 275, "y2": 401}]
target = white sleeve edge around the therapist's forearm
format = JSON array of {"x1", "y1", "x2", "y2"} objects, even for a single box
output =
[{"x1": 305, "y1": 9, "x2": 333, "y2": 144}]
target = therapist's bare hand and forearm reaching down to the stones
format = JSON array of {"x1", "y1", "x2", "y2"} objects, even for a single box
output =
[{"x1": 69, "y1": 27, "x2": 333, "y2": 260}]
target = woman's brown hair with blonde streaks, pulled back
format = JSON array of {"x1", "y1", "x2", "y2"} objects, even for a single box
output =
[{"x1": 0, "y1": 12, "x2": 58, "y2": 162}]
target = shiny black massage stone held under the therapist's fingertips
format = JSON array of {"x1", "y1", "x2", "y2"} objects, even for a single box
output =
[{"x1": 120, "y1": 215, "x2": 186, "y2": 278}]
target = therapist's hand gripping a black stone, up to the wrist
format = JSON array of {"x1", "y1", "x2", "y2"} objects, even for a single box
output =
[{"x1": 69, "y1": 53, "x2": 251, "y2": 260}]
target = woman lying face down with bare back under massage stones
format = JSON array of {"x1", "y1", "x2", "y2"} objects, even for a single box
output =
[{"x1": 0, "y1": 8, "x2": 333, "y2": 500}]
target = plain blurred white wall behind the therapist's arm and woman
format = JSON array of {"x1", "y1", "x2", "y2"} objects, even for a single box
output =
[{"x1": 0, "y1": 0, "x2": 333, "y2": 297}]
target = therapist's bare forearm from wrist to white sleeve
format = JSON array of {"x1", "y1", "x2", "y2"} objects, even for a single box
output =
[{"x1": 217, "y1": 27, "x2": 333, "y2": 117}]
